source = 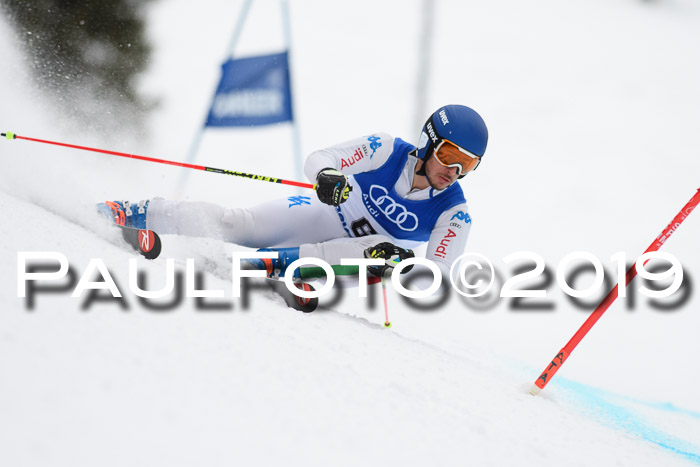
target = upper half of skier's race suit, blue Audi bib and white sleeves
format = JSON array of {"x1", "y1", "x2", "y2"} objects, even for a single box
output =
[{"x1": 304, "y1": 133, "x2": 471, "y2": 273}]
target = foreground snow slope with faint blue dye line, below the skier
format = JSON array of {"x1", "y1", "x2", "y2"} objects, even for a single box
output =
[{"x1": 0, "y1": 190, "x2": 700, "y2": 466}]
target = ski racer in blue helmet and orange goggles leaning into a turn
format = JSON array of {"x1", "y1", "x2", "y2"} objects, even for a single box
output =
[{"x1": 98, "y1": 105, "x2": 488, "y2": 284}]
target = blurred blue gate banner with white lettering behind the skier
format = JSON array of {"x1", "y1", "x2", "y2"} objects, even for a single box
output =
[{"x1": 205, "y1": 52, "x2": 293, "y2": 127}]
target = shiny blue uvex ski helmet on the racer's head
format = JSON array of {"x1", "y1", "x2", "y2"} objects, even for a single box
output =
[{"x1": 418, "y1": 105, "x2": 489, "y2": 178}]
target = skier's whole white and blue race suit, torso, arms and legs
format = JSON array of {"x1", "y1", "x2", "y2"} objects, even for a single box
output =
[{"x1": 146, "y1": 133, "x2": 471, "y2": 274}]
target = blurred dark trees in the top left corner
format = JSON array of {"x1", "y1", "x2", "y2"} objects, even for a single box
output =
[{"x1": 0, "y1": 0, "x2": 150, "y2": 132}]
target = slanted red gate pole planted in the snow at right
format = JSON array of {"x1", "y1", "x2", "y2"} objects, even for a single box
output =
[{"x1": 530, "y1": 188, "x2": 700, "y2": 396}]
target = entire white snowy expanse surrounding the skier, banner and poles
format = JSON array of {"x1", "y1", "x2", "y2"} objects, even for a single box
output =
[{"x1": 0, "y1": 0, "x2": 700, "y2": 466}]
